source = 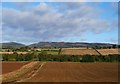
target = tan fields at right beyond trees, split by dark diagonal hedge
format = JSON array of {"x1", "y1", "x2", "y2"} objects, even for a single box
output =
[{"x1": 61, "y1": 48, "x2": 119, "y2": 55}]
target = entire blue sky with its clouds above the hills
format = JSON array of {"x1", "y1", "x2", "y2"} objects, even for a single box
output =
[{"x1": 0, "y1": 2, "x2": 118, "y2": 44}]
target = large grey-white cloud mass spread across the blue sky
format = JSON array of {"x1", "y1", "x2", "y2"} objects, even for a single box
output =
[{"x1": 2, "y1": 3, "x2": 116, "y2": 42}]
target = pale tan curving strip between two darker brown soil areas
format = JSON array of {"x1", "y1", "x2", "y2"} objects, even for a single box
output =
[{"x1": 2, "y1": 62, "x2": 40, "y2": 83}]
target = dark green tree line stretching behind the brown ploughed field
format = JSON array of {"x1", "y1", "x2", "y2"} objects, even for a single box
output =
[{"x1": 2, "y1": 52, "x2": 120, "y2": 62}]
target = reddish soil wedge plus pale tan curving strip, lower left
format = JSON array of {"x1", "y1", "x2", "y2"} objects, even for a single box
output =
[{"x1": 0, "y1": 62, "x2": 38, "y2": 82}]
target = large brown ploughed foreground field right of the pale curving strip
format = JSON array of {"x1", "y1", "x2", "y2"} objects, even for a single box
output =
[{"x1": 1, "y1": 62, "x2": 118, "y2": 84}]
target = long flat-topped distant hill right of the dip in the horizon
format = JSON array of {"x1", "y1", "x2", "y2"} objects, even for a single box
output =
[{"x1": 29, "y1": 42, "x2": 113, "y2": 48}]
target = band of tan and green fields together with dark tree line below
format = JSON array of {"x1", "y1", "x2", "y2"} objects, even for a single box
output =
[{"x1": 1, "y1": 48, "x2": 120, "y2": 62}]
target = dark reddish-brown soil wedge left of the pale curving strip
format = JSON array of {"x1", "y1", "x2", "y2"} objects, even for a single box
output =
[{"x1": 2, "y1": 62, "x2": 29, "y2": 74}]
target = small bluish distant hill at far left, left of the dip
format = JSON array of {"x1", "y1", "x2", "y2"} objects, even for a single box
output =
[{"x1": 0, "y1": 42, "x2": 25, "y2": 48}]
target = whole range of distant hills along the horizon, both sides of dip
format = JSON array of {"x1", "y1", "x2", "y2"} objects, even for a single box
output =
[{"x1": 0, "y1": 42, "x2": 114, "y2": 48}]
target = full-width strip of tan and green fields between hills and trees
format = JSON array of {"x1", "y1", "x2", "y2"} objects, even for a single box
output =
[{"x1": 0, "y1": 48, "x2": 119, "y2": 55}]
